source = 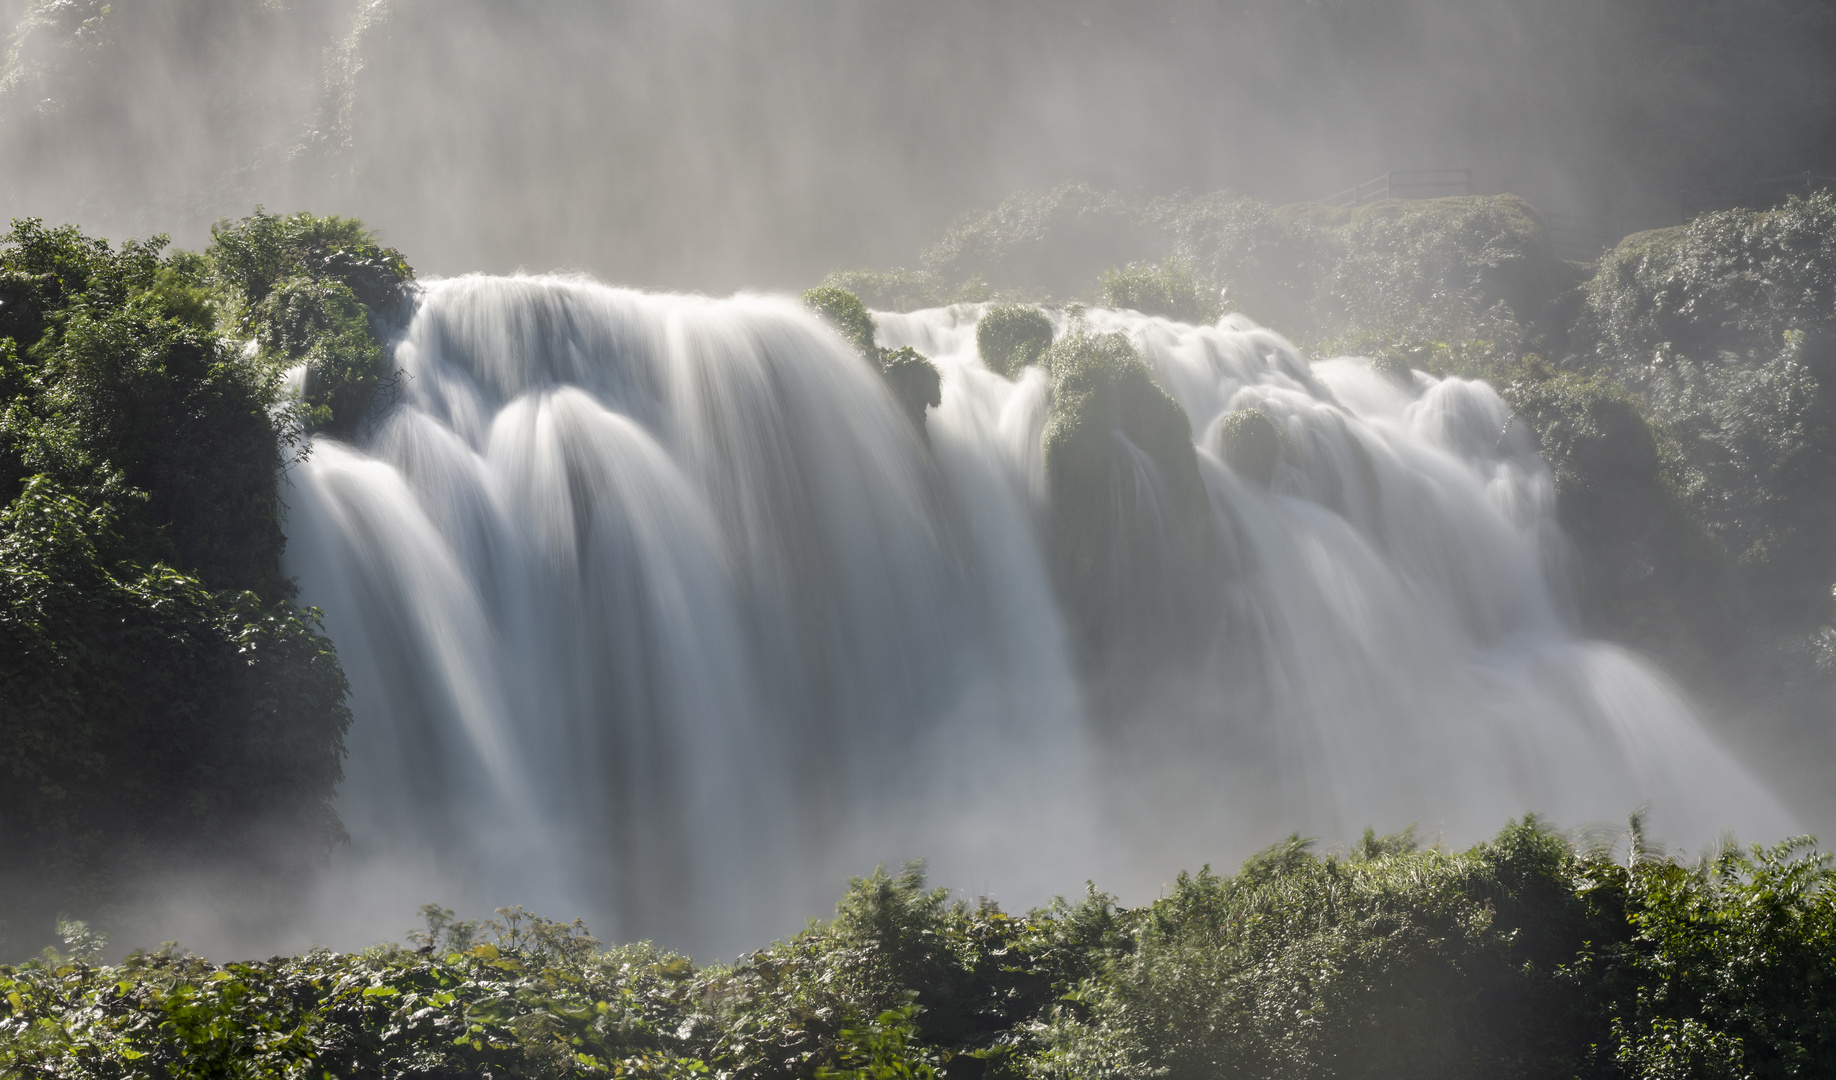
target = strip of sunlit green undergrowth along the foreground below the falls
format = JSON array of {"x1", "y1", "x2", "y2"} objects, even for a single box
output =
[{"x1": 0, "y1": 819, "x2": 1836, "y2": 1080}]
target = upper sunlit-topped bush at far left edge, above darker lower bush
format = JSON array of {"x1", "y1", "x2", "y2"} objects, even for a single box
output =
[{"x1": 0, "y1": 220, "x2": 281, "y2": 595}]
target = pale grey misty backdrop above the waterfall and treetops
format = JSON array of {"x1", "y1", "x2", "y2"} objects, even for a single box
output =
[{"x1": 0, "y1": 0, "x2": 1836, "y2": 292}]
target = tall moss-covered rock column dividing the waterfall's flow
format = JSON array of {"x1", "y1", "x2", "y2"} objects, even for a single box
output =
[{"x1": 1045, "y1": 325, "x2": 1215, "y2": 714}]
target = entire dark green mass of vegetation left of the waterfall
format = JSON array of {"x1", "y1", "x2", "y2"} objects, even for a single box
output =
[{"x1": 0, "y1": 211, "x2": 409, "y2": 951}]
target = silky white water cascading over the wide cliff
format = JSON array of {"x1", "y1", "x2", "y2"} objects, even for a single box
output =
[{"x1": 288, "y1": 277, "x2": 1788, "y2": 953}]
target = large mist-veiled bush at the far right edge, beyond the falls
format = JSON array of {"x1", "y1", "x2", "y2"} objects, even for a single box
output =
[{"x1": 1584, "y1": 193, "x2": 1836, "y2": 630}]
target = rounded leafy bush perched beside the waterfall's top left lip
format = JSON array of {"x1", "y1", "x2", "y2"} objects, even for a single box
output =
[{"x1": 206, "y1": 206, "x2": 413, "y2": 433}]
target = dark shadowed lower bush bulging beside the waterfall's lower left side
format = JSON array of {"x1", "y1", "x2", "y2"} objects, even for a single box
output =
[{"x1": 0, "y1": 476, "x2": 351, "y2": 933}]
